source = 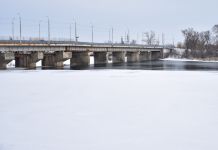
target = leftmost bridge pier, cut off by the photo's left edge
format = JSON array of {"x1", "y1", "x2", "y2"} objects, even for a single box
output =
[{"x1": 0, "y1": 52, "x2": 15, "y2": 69}]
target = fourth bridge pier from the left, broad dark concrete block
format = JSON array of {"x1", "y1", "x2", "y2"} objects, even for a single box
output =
[{"x1": 70, "y1": 52, "x2": 90, "y2": 68}]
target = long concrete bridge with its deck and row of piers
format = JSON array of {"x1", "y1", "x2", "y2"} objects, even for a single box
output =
[{"x1": 0, "y1": 41, "x2": 163, "y2": 69}]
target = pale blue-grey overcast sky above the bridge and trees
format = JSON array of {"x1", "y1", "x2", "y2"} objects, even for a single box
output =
[{"x1": 0, "y1": 0, "x2": 218, "y2": 43}]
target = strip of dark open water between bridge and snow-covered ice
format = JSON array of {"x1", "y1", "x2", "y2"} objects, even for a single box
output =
[{"x1": 0, "y1": 60, "x2": 218, "y2": 71}]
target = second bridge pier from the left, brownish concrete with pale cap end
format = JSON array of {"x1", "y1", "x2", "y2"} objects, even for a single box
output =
[{"x1": 15, "y1": 52, "x2": 43, "y2": 69}]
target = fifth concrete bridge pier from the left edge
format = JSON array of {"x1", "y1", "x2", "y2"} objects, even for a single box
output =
[{"x1": 94, "y1": 52, "x2": 108, "y2": 65}]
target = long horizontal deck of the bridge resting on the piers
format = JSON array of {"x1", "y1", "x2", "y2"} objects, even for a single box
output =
[{"x1": 0, "y1": 41, "x2": 167, "y2": 52}]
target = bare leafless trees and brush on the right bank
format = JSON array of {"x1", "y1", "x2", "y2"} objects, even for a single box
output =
[{"x1": 177, "y1": 25, "x2": 218, "y2": 58}]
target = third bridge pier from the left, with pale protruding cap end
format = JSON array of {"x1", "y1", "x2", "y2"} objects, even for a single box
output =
[{"x1": 42, "y1": 51, "x2": 72, "y2": 68}]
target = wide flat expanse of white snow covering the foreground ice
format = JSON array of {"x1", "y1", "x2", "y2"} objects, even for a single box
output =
[{"x1": 0, "y1": 70, "x2": 218, "y2": 150}]
